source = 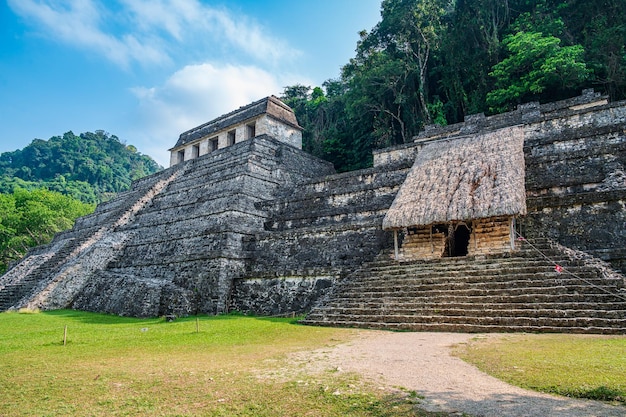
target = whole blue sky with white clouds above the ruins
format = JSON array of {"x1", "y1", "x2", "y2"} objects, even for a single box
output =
[{"x1": 0, "y1": 0, "x2": 380, "y2": 166}]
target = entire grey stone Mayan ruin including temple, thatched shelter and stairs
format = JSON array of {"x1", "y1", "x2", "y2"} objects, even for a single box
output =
[{"x1": 0, "y1": 90, "x2": 626, "y2": 333}]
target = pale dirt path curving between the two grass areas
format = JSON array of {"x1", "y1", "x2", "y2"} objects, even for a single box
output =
[{"x1": 298, "y1": 331, "x2": 626, "y2": 417}]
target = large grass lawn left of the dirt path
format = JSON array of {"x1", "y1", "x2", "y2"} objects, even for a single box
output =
[{"x1": 0, "y1": 310, "x2": 440, "y2": 417}]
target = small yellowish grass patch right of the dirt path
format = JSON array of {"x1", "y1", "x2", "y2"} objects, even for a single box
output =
[{"x1": 456, "y1": 334, "x2": 626, "y2": 404}]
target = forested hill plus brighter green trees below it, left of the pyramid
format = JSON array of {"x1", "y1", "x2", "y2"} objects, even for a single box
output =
[{"x1": 0, "y1": 131, "x2": 162, "y2": 274}]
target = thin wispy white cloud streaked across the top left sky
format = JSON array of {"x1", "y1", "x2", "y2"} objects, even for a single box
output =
[{"x1": 8, "y1": 0, "x2": 300, "y2": 67}]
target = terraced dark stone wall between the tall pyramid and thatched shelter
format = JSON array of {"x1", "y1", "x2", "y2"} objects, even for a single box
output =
[{"x1": 230, "y1": 161, "x2": 412, "y2": 314}]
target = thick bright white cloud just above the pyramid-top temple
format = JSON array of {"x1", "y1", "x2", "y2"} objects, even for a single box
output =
[{"x1": 129, "y1": 63, "x2": 283, "y2": 166}]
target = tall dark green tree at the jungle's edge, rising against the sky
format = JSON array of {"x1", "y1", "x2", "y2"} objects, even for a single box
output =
[{"x1": 352, "y1": 0, "x2": 454, "y2": 128}]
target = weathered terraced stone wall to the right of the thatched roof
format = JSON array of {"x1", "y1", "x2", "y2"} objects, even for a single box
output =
[{"x1": 523, "y1": 102, "x2": 626, "y2": 272}]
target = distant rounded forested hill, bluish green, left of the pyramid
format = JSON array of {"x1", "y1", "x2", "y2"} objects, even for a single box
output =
[{"x1": 0, "y1": 130, "x2": 162, "y2": 203}]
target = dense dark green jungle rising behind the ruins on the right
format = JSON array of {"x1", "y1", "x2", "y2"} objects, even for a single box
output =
[{"x1": 282, "y1": 0, "x2": 626, "y2": 171}]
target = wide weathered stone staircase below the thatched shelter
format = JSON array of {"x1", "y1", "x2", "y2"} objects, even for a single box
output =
[{"x1": 302, "y1": 240, "x2": 626, "y2": 334}]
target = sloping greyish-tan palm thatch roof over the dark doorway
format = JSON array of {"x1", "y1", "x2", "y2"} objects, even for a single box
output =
[{"x1": 383, "y1": 126, "x2": 526, "y2": 230}]
